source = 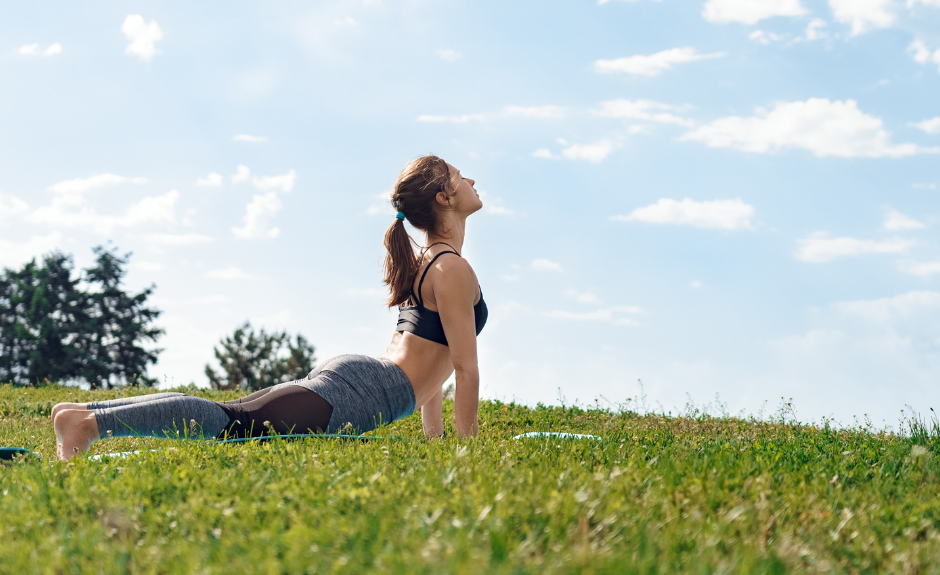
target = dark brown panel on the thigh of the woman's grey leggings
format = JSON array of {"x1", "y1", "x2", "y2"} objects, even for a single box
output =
[{"x1": 219, "y1": 384, "x2": 333, "y2": 437}]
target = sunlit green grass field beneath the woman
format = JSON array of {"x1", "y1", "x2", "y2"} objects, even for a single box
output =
[{"x1": 0, "y1": 385, "x2": 940, "y2": 574}]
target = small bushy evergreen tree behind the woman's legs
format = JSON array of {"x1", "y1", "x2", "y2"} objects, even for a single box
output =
[{"x1": 206, "y1": 322, "x2": 316, "y2": 391}]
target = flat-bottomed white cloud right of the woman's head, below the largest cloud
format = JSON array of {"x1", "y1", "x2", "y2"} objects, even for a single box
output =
[{"x1": 611, "y1": 198, "x2": 754, "y2": 230}]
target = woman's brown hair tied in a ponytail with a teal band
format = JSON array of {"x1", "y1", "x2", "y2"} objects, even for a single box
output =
[{"x1": 384, "y1": 156, "x2": 454, "y2": 307}]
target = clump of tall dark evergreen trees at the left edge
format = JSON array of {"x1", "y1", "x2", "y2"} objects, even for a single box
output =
[{"x1": 0, "y1": 247, "x2": 163, "y2": 388}]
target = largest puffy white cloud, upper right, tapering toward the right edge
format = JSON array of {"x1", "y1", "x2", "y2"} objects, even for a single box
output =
[{"x1": 681, "y1": 98, "x2": 940, "y2": 158}]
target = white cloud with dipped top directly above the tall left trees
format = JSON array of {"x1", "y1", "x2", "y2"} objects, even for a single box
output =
[{"x1": 27, "y1": 190, "x2": 180, "y2": 234}]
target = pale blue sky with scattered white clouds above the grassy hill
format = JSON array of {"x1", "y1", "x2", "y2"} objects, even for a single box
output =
[{"x1": 0, "y1": 0, "x2": 940, "y2": 428}]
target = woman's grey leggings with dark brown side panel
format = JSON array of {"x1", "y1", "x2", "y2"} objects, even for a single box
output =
[{"x1": 88, "y1": 355, "x2": 415, "y2": 439}]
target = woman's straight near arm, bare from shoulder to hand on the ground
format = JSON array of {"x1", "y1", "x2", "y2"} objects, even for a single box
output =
[{"x1": 434, "y1": 258, "x2": 480, "y2": 438}]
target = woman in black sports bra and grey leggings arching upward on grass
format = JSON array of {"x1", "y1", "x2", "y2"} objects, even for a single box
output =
[{"x1": 52, "y1": 156, "x2": 487, "y2": 459}]
